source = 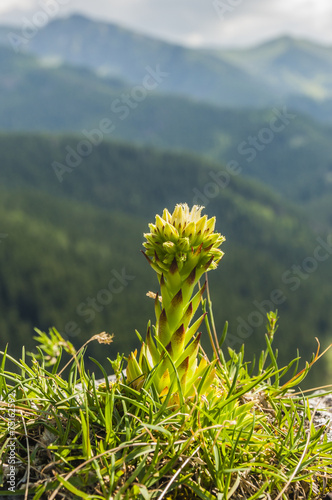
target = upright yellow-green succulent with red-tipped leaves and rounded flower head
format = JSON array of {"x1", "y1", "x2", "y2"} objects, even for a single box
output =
[{"x1": 127, "y1": 204, "x2": 225, "y2": 404}]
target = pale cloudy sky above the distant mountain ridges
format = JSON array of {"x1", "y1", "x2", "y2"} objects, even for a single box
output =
[{"x1": 0, "y1": 0, "x2": 332, "y2": 46}]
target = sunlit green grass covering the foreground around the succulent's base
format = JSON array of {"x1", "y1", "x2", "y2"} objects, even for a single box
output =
[{"x1": 0, "y1": 306, "x2": 332, "y2": 500}]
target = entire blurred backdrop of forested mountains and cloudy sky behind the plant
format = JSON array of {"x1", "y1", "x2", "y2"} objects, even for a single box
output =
[{"x1": 0, "y1": 0, "x2": 332, "y2": 387}]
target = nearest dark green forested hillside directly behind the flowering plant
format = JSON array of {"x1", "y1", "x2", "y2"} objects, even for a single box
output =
[{"x1": 0, "y1": 134, "x2": 332, "y2": 385}]
